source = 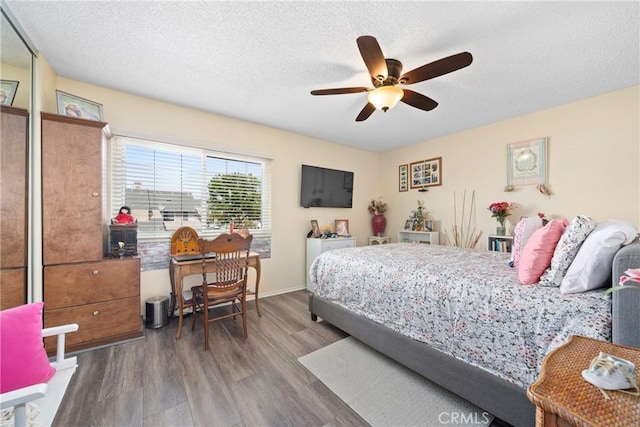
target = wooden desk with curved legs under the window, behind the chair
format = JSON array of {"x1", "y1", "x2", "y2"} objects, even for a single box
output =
[{"x1": 169, "y1": 252, "x2": 262, "y2": 338}]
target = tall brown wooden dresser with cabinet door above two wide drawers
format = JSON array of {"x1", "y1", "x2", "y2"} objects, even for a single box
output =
[{"x1": 41, "y1": 113, "x2": 142, "y2": 352}]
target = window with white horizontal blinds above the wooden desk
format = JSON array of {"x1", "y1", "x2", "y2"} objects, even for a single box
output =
[{"x1": 110, "y1": 136, "x2": 271, "y2": 239}]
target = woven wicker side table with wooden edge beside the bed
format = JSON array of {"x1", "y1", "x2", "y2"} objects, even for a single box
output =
[{"x1": 527, "y1": 336, "x2": 640, "y2": 427}]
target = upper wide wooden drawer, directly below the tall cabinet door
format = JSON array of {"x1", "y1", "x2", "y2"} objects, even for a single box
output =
[{"x1": 44, "y1": 258, "x2": 140, "y2": 310}]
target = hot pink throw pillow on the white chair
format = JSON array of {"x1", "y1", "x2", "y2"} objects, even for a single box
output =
[{"x1": 0, "y1": 302, "x2": 56, "y2": 393}]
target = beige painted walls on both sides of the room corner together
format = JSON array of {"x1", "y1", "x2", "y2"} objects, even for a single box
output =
[{"x1": 31, "y1": 53, "x2": 640, "y2": 310}]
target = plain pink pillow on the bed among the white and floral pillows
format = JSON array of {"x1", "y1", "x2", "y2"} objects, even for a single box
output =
[{"x1": 518, "y1": 219, "x2": 569, "y2": 285}]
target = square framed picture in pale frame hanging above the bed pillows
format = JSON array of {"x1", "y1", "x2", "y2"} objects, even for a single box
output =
[{"x1": 507, "y1": 138, "x2": 547, "y2": 186}]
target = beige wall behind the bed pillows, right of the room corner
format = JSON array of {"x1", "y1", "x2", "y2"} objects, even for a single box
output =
[{"x1": 381, "y1": 86, "x2": 640, "y2": 247}]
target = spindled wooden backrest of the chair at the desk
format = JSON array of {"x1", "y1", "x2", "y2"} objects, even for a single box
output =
[{"x1": 198, "y1": 233, "x2": 253, "y2": 289}]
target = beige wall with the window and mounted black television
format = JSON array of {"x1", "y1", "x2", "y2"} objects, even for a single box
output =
[{"x1": 37, "y1": 70, "x2": 380, "y2": 310}]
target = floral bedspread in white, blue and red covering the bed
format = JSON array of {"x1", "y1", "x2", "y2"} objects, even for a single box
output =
[{"x1": 310, "y1": 243, "x2": 611, "y2": 387}]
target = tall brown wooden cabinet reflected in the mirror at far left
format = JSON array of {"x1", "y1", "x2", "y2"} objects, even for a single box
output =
[{"x1": 0, "y1": 105, "x2": 29, "y2": 310}]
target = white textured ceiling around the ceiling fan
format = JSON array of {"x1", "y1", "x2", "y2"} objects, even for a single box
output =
[{"x1": 5, "y1": 1, "x2": 640, "y2": 151}]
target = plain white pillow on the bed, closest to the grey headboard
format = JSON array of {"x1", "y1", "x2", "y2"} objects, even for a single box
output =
[{"x1": 560, "y1": 220, "x2": 637, "y2": 294}]
